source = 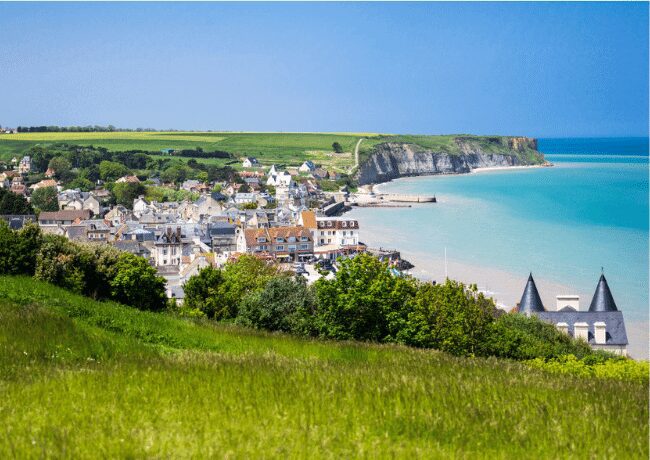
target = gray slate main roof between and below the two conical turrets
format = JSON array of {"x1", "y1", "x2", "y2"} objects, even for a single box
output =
[{"x1": 535, "y1": 309, "x2": 628, "y2": 345}]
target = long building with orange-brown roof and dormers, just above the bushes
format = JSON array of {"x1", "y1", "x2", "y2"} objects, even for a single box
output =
[{"x1": 237, "y1": 226, "x2": 314, "y2": 262}]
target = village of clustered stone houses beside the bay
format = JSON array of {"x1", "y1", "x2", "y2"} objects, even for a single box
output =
[{"x1": 0, "y1": 156, "x2": 410, "y2": 302}]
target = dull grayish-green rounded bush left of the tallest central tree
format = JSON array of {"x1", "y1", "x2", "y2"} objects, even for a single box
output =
[{"x1": 237, "y1": 277, "x2": 315, "y2": 335}]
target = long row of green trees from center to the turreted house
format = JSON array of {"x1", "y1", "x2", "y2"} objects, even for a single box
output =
[{"x1": 182, "y1": 254, "x2": 594, "y2": 360}]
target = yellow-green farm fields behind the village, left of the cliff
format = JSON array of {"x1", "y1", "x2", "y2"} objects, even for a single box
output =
[{"x1": 0, "y1": 132, "x2": 377, "y2": 171}]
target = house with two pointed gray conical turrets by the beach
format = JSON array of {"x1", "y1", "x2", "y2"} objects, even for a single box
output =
[{"x1": 515, "y1": 273, "x2": 628, "y2": 356}]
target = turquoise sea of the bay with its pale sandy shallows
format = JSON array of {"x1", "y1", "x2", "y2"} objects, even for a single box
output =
[{"x1": 350, "y1": 137, "x2": 649, "y2": 359}]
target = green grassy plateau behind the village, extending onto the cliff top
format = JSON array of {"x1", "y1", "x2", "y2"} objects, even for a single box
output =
[{"x1": 0, "y1": 132, "x2": 534, "y2": 172}]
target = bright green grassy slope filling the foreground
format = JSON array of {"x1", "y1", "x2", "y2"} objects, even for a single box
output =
[{"x1": 0, "y1": 277, "x2": 648, "y2": 458}]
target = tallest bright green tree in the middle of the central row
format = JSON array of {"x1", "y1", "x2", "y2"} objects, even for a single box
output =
[{"x1": 315, "y1": 254, "x2": 417, "y2": 341}]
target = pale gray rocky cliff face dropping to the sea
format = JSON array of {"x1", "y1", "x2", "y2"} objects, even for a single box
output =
[{"x1": 357, "y1": 137, "x2": 544, "y2": 185}]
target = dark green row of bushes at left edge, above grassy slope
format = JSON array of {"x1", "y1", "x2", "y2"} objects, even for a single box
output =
[{"x1": 0, "y1": 221, "x2": 167, "y2": 311}]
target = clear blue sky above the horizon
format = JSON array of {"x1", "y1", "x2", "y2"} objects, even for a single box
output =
[{"x1": 0, "y1": 3, "x2": 648, "y2": 137}]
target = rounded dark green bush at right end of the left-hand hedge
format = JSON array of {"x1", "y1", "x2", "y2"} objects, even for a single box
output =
[{"x1": 110, "y1": 252, "x2": 166, "y2": 311}]
